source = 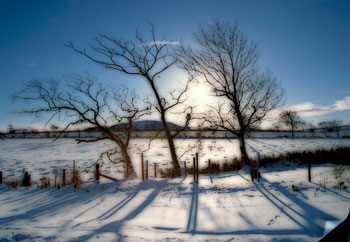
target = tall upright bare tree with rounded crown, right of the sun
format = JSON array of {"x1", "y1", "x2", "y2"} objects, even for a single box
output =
[{"x1": 177, "y1": 20, "x2": 284, "y2": 163}]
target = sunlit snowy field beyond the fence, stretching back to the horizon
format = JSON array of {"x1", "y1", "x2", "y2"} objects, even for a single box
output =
[{"x1": 0, "y1": 138, "x2": 350, "y2": 181}]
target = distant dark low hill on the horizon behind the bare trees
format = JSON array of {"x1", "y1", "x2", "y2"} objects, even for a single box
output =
[{"x1": 86, "y1": 120, "x2": 189, "y2": 132}]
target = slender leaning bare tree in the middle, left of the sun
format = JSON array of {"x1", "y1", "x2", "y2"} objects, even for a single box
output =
[{"x1": 67, "y1": 25, "x2": 193, "y2": 176}]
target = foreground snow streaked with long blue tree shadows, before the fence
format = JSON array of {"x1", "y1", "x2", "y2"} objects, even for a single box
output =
[{"x1": 0, "y1": 164, "x2": 350, "y2": 241}]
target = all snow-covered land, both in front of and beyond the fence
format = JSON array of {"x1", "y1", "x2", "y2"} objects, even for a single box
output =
[{"x1": 0, "y1": 139, "x2": 350, "y2": 241}]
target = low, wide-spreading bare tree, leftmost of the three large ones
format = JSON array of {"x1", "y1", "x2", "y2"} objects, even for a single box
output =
[{"x1": 12, "y1": 75, "x2": 150, "y2": 177}]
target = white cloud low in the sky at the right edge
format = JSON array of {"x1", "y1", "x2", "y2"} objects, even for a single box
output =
[{"x1": 288, "y1": 96, "x2": 350, "y2": 117}]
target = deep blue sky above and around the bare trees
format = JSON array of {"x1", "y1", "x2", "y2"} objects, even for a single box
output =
[{"x1": 0, "y1": 0, "x2": 350, "y2": 130}]
